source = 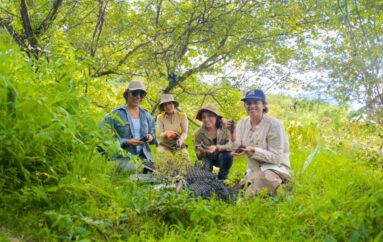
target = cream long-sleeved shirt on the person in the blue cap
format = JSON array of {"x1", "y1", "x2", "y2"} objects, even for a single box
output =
[{"x1": 234, "y1": 114, "x2": 290, "y2": 177}]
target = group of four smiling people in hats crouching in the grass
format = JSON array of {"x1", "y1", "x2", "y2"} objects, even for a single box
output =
[{"x1": 102, "y1": 81, "x2": 290, "y2": 197}]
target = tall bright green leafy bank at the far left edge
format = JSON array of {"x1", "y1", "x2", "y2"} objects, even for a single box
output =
[{"x1": 0, "y1": 38, "x2": 97, "y2": 189}]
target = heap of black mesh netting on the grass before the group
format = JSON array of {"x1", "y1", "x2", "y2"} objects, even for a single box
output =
[{"x1": 185, "y1": 167, "x2": 238, "y2": 203}]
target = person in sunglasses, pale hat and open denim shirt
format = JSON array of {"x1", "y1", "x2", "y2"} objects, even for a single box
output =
[{"x1": 101, "y1": 81, "x2": 156, "y2": 170}]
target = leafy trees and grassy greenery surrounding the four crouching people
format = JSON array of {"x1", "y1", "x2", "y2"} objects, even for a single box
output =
[{"x1": 0, "y1": 0, "x2": 383, "y2": 241}]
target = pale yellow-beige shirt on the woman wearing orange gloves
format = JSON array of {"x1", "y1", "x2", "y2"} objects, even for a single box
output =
[{"x1": 156, "y1": 110, "x2": 188, "y2": 140}]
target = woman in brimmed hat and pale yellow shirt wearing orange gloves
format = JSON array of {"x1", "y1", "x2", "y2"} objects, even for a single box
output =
[{"x1": 156, "y1": 94, "x2": 188, "y2": 155}]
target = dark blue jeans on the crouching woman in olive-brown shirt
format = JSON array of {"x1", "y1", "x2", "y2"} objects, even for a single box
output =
[{"x1": 204, "y1": 151, "x2": 233, "y2": 180}]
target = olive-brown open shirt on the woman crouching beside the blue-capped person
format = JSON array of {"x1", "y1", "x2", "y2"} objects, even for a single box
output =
[{"x1": 194, "y1": 124, "x2": 233, "y2": 159}]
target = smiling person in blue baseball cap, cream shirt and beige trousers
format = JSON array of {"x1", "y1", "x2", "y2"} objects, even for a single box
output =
[{"x1": 233, "y1": 89, "x2": 291, "y2": 197}]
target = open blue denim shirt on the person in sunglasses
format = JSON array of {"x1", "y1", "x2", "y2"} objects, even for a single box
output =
[{"x1": 101, "y1": 104, "x2": 156, "y2": 162}]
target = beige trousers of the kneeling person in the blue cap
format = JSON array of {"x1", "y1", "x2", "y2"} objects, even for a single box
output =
[{"x1": 239, "y1": 170, "x2": 282, "y2": 198}]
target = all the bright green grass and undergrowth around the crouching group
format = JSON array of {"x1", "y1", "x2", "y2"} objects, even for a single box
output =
[{"x1": 0, "y1": 36, "x2": 383, "y2": 241}]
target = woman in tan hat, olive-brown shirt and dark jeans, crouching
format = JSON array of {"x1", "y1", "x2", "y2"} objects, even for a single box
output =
[{"x1": 194, "y1": 105, "x2": 233, "y2": 180}]
